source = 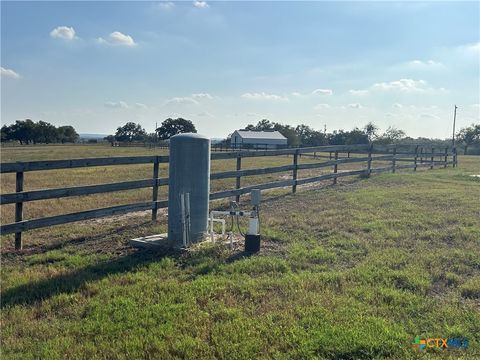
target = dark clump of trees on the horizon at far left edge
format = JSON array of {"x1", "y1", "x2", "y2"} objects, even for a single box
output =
[{"x1": 1, "y1": 119, "x2": 79, "y2": 145}]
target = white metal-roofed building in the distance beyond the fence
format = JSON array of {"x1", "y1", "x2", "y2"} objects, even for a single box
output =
[{"x1": 230, "y1": 130, "x2": 287, "y2": 149}]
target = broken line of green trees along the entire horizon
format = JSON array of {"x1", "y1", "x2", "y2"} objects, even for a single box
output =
[{"x1": 1, "y1": 118, "x2": 480, "y2": 154}]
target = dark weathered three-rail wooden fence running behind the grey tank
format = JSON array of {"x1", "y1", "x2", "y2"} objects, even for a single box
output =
[{"x1": 0, "y1": 145, "x2": 457, "y2": 249}]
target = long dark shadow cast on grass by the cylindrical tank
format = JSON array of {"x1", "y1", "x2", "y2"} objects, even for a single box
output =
[{"x1": 0, "y1": 250, "x2": 175, "y2": 309}]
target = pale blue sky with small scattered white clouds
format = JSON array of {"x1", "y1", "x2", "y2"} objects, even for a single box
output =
[{"x1": 1, "y1": 1, "x2": 480, "y2": 138}]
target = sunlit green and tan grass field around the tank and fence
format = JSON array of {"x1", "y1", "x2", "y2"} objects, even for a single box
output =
[{"x1": 1, "y1": 147, "x2": 480, "y2": 359}]
